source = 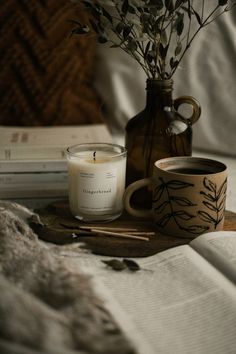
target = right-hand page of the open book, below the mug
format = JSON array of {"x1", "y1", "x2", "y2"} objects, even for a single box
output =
[{"x1": 190, "y1": 231, "x2": 236, "y2": 284}]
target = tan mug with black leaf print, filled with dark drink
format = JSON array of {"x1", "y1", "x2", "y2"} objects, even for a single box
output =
[{"x1": 124, "y1": 157, "x2": 227, "y2": 238}]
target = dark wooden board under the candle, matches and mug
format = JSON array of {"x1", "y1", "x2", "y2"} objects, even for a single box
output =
[{"x1": 32, "y1": 201, "x2": 236, "y2": 258}]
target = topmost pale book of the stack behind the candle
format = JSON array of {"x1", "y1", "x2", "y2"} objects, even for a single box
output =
[{"x1": 0, "y1": 124, "x2": 112, "y2": 160}]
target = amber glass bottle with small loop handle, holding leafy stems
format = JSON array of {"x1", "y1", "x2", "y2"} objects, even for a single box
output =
[{"x1": 126, "y1": 79, "x2": 201, "y2": 206}]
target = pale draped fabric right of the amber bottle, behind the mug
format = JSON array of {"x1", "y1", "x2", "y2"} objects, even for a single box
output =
[{"x1": 174, "y1": 4, "x2": 236, "y2": 155}]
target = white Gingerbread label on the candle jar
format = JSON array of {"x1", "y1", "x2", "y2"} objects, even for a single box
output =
[{"x1": 78, "y1": 169, "x2": 117, "y2": 212}]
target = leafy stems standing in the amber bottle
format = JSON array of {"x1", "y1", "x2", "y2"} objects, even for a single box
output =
[{"x1": 72, "y1": 0, "x2": 236, "y2": 79}]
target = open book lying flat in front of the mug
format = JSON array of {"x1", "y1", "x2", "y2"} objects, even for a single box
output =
[{"x1": 65, "y1": 231, "x2": 236, "y2": 354}]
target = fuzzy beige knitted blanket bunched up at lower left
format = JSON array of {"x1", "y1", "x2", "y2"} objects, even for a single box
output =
[{"x1": 0, "y1": 202, "x2": 134, "y2": 354}]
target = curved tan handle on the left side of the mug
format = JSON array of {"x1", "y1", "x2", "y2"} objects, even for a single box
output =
[{"x1": 123, "y1": 177, "x2": 152, "y2": 218}]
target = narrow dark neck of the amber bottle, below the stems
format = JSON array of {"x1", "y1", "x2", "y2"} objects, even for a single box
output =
[{"x1": 146, "y1": 79, "x2": 173, "y2": 108}]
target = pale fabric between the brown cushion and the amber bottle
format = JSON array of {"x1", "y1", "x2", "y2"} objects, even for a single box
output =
[{"x1": 94, "y1": 45, "x2": 146, "y2": 135}]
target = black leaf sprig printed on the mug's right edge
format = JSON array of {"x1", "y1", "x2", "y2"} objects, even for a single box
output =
[{"x1": 198, "y1": 177, "x2": 227, "y2": 229}]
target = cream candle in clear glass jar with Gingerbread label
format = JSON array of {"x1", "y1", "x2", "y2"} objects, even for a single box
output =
[{"x1": 67, "y1": 143, "x2": 126, "y2": 222}]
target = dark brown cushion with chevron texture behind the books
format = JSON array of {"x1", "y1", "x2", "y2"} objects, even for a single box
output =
[{"x1": 0, "y1": 0, "x2": 101, "y2": 126}]
